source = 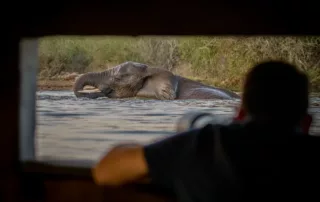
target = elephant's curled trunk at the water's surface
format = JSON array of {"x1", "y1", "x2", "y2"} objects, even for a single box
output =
[{"x1": 73, "y1": 72, "x2": 105, "y2": 99}]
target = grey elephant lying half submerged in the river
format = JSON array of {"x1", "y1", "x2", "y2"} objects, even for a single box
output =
[{"x1": 73, "y1": 62, "x2": 240, "y2": 100}]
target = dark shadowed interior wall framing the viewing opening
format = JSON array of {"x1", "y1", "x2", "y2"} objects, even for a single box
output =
[{"x1": 0, "y1": 1, "x2": 320, "y2": 202}]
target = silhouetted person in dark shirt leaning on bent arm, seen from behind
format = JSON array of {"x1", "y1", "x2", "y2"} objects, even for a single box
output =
[{"x1": 93, "y1": 61, "x2": 320, "y2": 202}]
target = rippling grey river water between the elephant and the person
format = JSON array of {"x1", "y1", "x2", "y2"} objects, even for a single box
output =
[{"x1": 36, "y1": 91, "x2": 320, "y2": 166}]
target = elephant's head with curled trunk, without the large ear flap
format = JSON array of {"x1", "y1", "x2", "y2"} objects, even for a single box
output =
[{"x1": 73, "y1": 62, "x2": 166, "y2": 98}]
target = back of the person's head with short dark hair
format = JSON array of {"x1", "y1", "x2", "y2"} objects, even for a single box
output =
[{"x1": 243, "y1": 61, "x2": 309, "y2": 124}]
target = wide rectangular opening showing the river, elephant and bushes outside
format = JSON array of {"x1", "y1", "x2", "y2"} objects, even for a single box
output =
[{"x1": 20, "y1": 36, "x2": 320, "y2": 165}]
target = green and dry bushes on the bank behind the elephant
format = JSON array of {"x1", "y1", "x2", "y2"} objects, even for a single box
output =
[{"x1": 39, "y1": 36, "x2": 320, "y2": 90}]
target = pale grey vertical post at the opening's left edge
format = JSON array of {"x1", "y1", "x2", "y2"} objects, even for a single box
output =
[{"x1": 19, "y1": 38, "x2": 39, "y2": 162}]
